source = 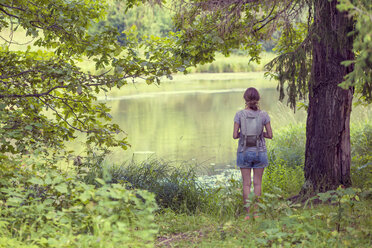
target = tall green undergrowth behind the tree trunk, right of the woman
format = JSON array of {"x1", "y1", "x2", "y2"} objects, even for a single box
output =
[{"x1": 263, "y1": 121, "x2": 372, "y2": 196}]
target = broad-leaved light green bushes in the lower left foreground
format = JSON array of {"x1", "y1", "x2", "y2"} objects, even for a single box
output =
[{"x1": 0, "y1": 162, "x2": 157, "y2": 247}]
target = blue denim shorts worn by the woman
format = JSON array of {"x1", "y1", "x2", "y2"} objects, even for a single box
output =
[{"x1": 236, "y1": 151, "x2": 269, "y2": 169}]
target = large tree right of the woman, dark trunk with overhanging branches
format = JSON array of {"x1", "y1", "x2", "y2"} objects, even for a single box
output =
[{"x1": 171, "y1": 0, "x2": 372, "y2": 195}]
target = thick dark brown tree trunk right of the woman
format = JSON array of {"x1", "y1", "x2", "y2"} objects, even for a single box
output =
[{"x1": 302, "y1": 0, "x2": 354, "y2": 194}]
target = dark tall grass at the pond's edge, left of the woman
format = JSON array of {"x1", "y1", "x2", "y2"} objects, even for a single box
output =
[{"x1": 86, "y1": 159, "x2": 212, "y2": 213}]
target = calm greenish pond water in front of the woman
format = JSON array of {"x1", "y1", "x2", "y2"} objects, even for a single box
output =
[{"x1": 94, "y1": 74, "x2": 305, "y2": 171}]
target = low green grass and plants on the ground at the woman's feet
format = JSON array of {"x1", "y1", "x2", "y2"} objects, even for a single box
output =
[{"x1": 156, "y1": 196, "x2": 372, "y2": 247}]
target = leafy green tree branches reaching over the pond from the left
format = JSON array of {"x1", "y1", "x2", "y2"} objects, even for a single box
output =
[{"x1": 0, "y1": 0, "x2": 183, "y2": 164}]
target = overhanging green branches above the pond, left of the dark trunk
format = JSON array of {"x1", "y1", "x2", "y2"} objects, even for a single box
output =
[{"x1": 171, "y1": 0, "x2": 312, "y2": 107}]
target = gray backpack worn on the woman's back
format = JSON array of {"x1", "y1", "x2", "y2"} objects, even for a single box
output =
[{"x1": 240, "y1": 111, "x2": 263, "y2": 151}]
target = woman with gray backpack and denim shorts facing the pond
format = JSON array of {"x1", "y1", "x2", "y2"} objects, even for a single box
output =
[{"x1": 233, "y1": 88, "x2": 273, "y2": 219}]
